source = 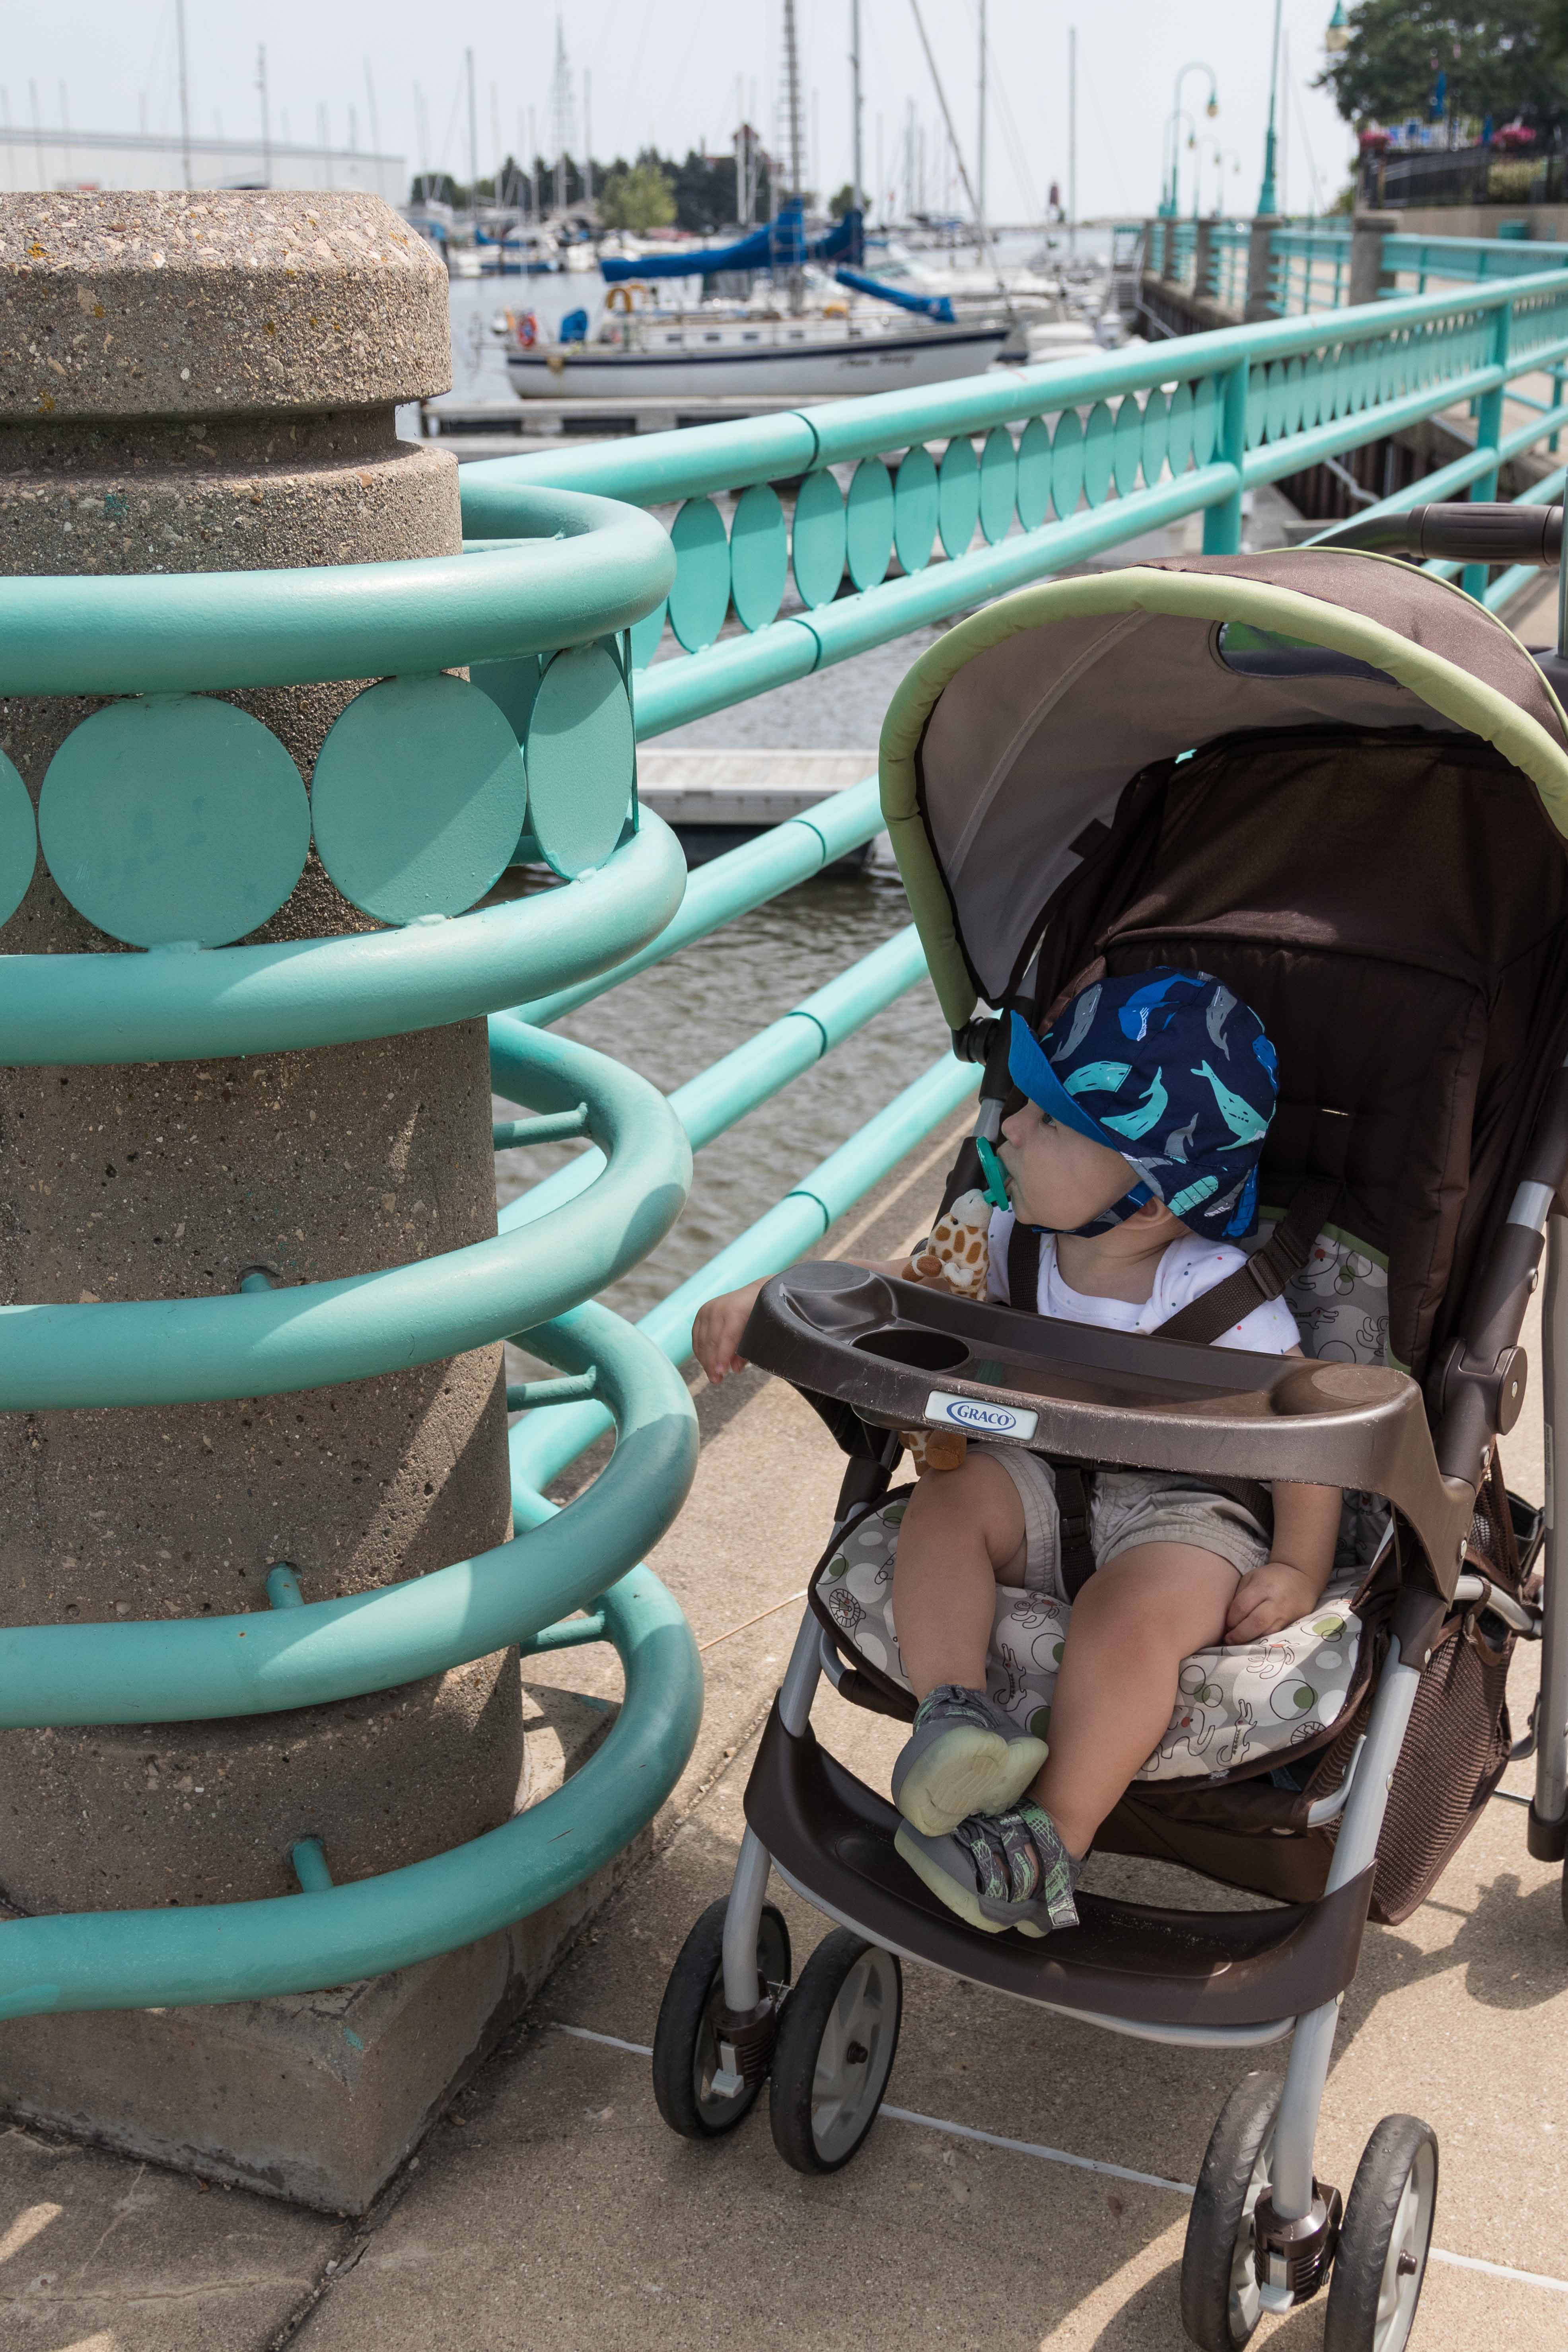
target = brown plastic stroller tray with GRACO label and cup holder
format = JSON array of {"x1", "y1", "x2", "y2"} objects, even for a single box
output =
[{"x1": 741, "y1": 1261, "x2": 1474, "y2": 1590}]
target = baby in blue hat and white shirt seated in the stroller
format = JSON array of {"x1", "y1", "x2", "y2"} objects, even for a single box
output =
[{"x1": 693, "y1": 969, "x2": 1340, "y2": 1936}]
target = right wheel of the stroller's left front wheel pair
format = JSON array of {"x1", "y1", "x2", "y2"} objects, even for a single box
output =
[{"x1": 769, "y1": 1926, "x2": 903, "y2": 2173}]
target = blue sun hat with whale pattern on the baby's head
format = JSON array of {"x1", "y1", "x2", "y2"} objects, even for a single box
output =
[{"x1": 1008, "y1": 967, "x2": 1279, "y2": 1239}]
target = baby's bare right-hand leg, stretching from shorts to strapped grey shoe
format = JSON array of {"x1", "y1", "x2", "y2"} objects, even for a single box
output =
[{"x1": 1034, "y1": 1543, "x2": 1237, "y2": 1856}]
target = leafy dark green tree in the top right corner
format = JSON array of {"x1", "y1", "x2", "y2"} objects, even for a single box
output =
[{"x1": 1319, "y1": 0, "x2": 1568, "y2": 132}]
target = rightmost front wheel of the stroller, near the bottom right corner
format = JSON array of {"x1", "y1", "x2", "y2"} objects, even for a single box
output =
[{"x1": 1323, "y1": 2115, "x2": 1436, "y2": 2352}]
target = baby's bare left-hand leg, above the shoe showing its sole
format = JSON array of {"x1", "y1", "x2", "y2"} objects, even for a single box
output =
[{"x1": 893, "y1": 1446, "x2": 1029, "y2": 1703}]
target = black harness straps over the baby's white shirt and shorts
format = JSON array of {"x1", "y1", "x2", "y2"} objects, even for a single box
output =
[{"x1": 1006, "y1": 1176, "x2": 1340, "y2": 1602}]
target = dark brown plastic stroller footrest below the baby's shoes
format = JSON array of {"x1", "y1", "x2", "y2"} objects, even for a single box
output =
[{"x1": 745, "y1": 1705, "x2": 1373, "y2": 2030}]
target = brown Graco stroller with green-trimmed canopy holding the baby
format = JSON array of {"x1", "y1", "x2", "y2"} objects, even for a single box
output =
[{"x1": 654, "y1": 519, "x2": 1568, "y2": 2352}]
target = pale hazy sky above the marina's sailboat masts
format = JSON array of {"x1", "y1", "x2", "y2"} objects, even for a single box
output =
[{"x1": 0, "y1": 0, "x2": 1352, "y2": 221}]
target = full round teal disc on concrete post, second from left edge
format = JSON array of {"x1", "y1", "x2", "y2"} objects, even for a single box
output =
[{"x1": 38, "y1": 694, "x2": 310, "y2": 948}]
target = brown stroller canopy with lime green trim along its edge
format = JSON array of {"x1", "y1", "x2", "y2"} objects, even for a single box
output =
[{"x1": 881, "y1": 548, "x2": 1568, "y2": 1028}]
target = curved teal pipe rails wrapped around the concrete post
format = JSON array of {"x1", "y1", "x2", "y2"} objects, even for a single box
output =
[{"x1": 0, "y1": 492, "x2": 700, "y2": 2015}]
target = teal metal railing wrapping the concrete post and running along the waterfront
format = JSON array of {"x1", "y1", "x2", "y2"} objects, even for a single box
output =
[{"x1": 0, "y1": 257, "x2": 1568, "y2": 2013}]
